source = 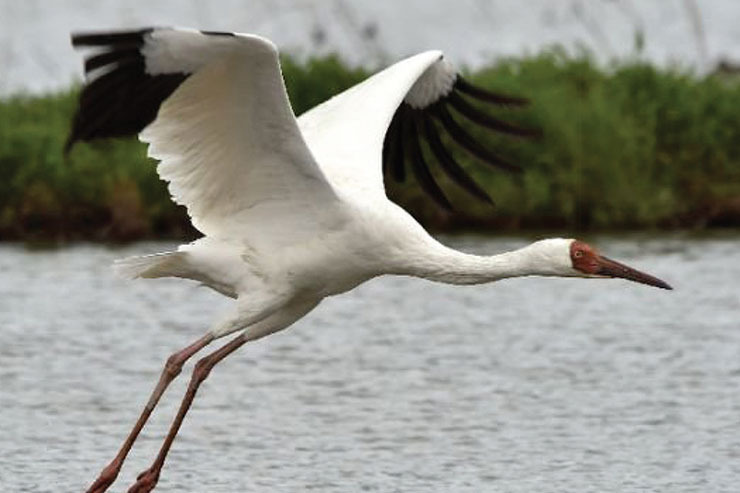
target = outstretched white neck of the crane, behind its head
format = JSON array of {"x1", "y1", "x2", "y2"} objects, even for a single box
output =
[{"x1": 408, "y1": 239, "x2": 560, "y2": 284}]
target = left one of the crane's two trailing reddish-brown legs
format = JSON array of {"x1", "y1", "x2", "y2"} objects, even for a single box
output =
[{"x1": 87, "y1": 333, "x2": 214, "y2": 493}]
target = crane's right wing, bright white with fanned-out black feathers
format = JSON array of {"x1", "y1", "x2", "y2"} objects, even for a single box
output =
[{"x1": 298, "y1": 51, "x2": 539, "y2": 210}]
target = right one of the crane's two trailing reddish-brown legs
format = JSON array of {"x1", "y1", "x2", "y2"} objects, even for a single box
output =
[{"x1": 128, "y1": 334, "x2": 250, "y2": 493}]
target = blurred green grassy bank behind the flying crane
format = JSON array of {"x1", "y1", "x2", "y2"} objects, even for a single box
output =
[{"x1": 0, "y1": 52, "x2": 740, "y2": 239}]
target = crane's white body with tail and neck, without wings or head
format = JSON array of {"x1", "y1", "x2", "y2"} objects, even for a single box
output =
[{"x1": 114, "y1": 194, "x2": 544, "y2": 337}]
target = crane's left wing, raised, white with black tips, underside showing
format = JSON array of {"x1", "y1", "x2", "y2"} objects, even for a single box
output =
[{"x1": 67, "y1": 28, "x2": 336, "y2": 238}]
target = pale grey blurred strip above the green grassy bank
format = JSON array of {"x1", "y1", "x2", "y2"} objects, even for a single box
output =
[{"x1": 0, "y1": 0, "x2": 740, "y2": 95}]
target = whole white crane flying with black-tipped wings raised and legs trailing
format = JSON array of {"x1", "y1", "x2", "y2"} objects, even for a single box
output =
[{"x1": 67, "y1": 28, "x2": 670, "y2": 493}]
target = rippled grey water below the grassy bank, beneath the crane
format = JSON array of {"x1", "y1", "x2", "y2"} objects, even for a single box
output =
[{"x1": 0, "y1": 236, "x2": 740, "y2": 493}]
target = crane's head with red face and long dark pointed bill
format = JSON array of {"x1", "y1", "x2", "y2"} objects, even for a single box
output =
[{"x1": 529, "y1": 238, "x2": 673, "y2": 289}]
